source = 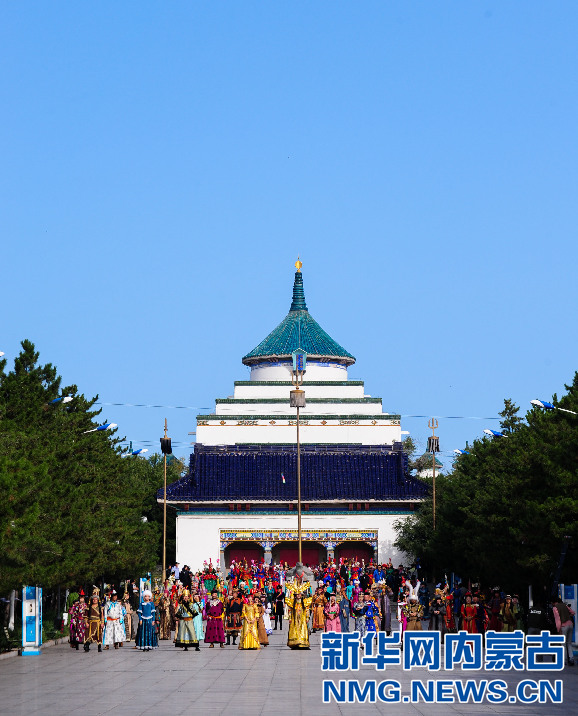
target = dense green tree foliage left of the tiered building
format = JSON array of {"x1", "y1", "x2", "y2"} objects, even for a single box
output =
[{"x1": 0, "y1": 341, "x2": 182, "y2": 593}]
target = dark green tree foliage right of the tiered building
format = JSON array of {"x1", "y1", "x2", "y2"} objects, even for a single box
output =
[{"x1": 396, "y1": 392, "x2": 578, "y2": 589}]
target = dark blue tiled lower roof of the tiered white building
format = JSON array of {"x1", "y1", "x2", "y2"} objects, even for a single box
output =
[{"x1": 158, "y1": 443, "x2": 428, "y2": 502}]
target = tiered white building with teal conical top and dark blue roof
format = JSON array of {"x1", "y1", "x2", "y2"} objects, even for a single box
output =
[{"x1": 158, "y1": 261, "x2": 428, "y2": 569}]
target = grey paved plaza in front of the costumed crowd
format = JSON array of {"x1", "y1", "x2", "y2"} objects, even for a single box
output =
[{"x1": 0, "y1": 625, "x2": 578, "y2": 716}]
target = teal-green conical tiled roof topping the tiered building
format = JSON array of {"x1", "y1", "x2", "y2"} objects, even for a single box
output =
[{"x1": 243, "y1": 270, "x2": 355, "y2": 365}]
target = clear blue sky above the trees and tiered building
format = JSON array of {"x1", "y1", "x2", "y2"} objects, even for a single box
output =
[{"x1": 0, "y1": 0, "x2": 578, "y2": 462}]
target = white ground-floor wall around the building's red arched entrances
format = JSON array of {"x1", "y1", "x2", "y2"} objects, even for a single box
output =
[{"x1": 177, "y1": 514, "x2": 407, "y2": 569}]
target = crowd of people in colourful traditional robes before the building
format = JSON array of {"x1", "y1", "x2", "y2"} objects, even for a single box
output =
[{"x1": 70, "y1": 560, "x2": 574, "y2": 664}]
